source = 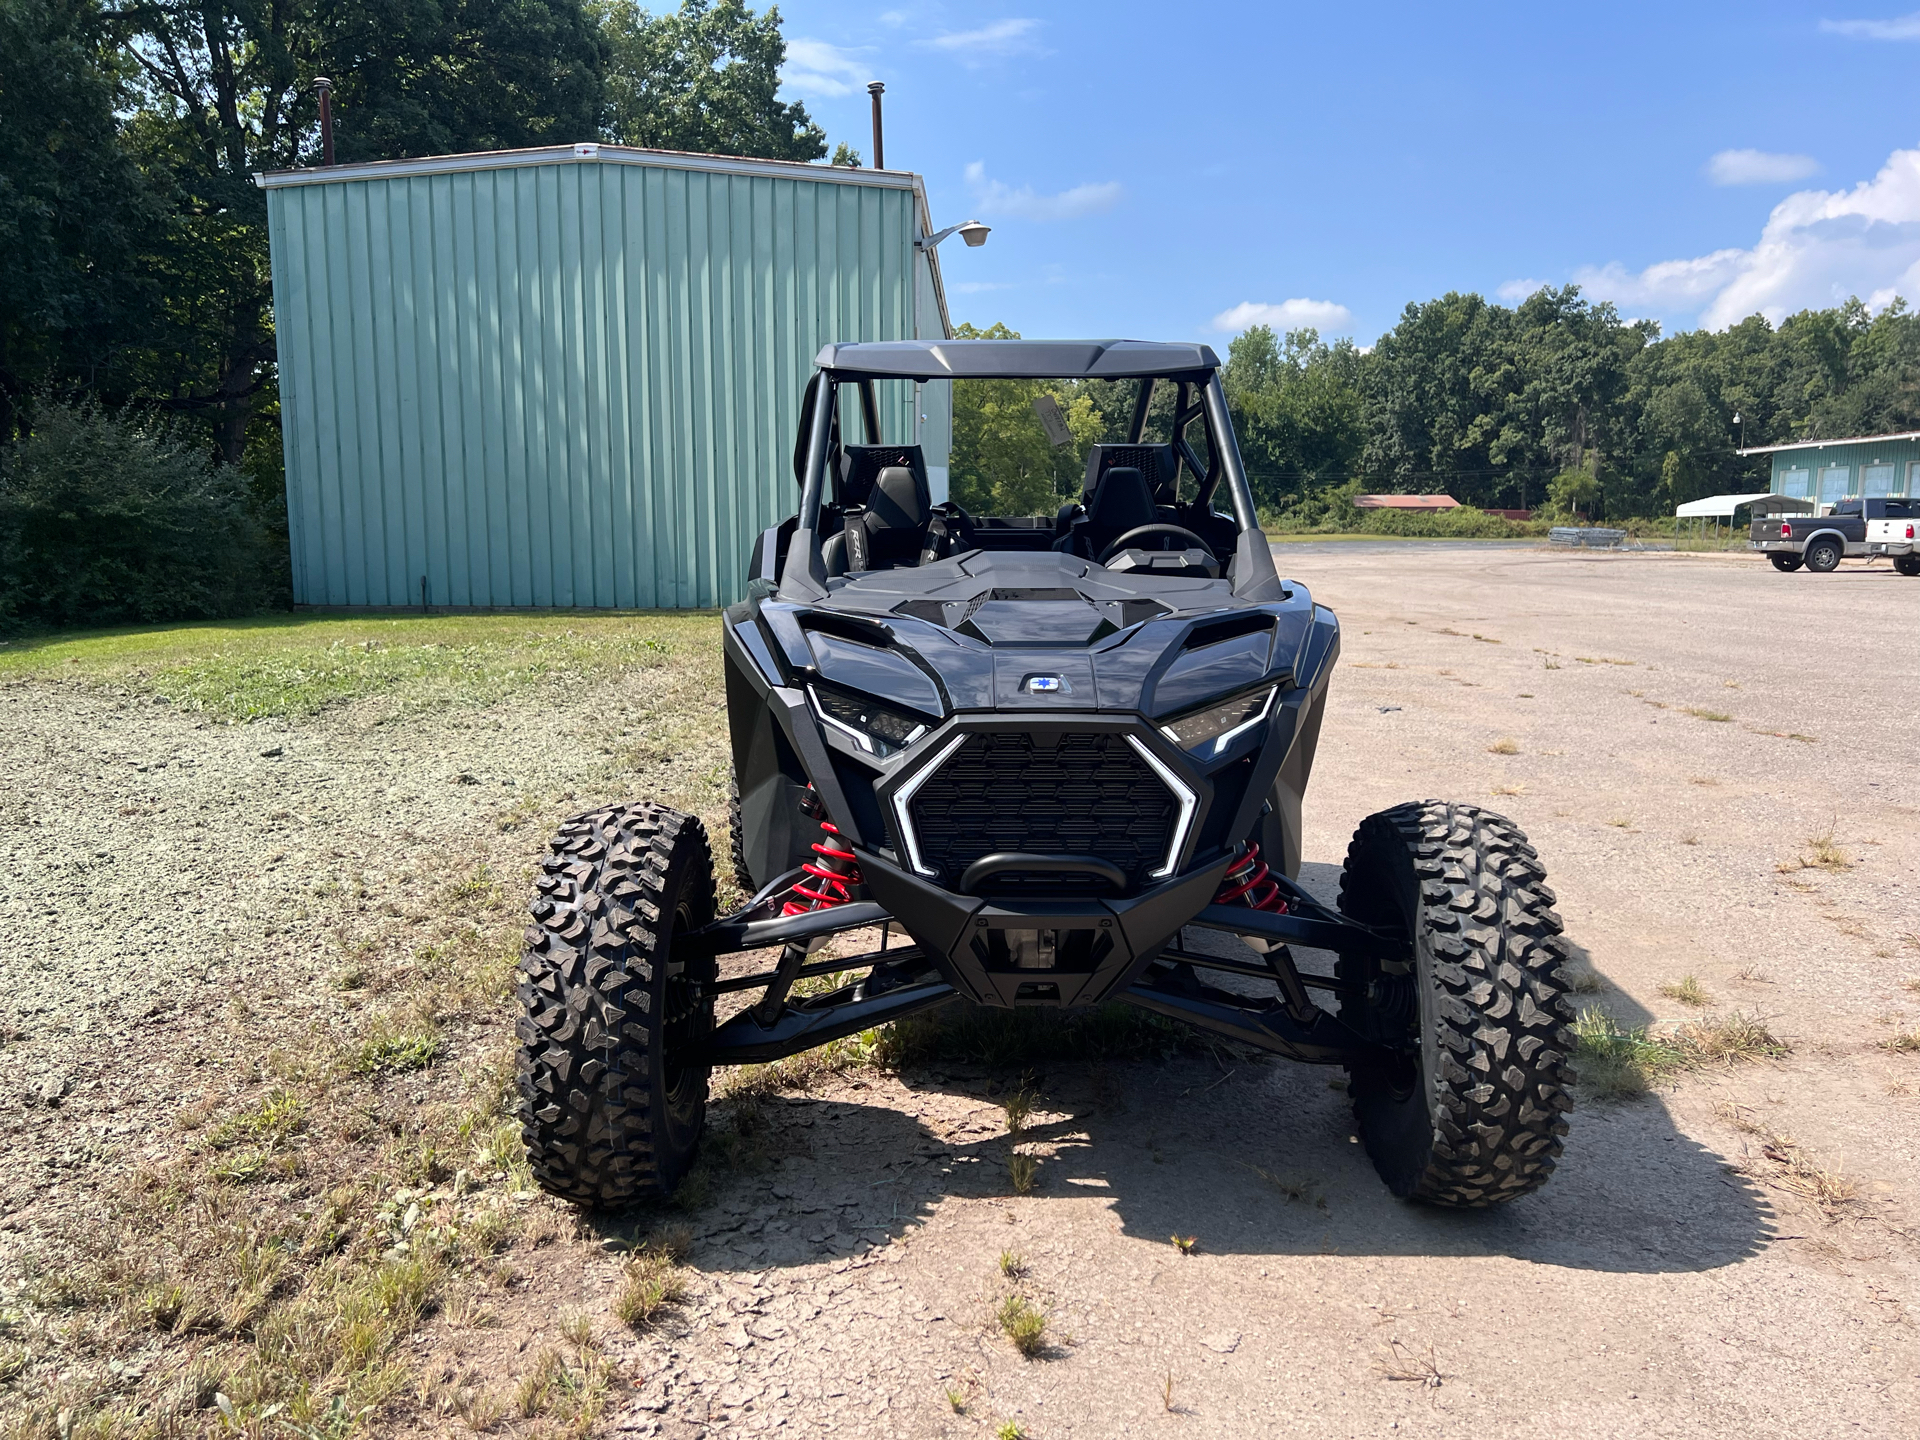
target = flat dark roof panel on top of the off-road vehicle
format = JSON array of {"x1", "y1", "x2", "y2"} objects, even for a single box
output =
[{"x1": 814, "y1": 340, "x2": 1219, "y2": 380}]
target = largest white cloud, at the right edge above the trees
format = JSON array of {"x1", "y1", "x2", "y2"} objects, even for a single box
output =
[{"x1": 1574, "y1": 150, "x2": 1920, "y2": 330}]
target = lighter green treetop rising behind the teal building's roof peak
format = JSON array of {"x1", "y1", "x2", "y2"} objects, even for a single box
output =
[{"x1": 595, "y1": 0, "x2": 825, "y2": 163}]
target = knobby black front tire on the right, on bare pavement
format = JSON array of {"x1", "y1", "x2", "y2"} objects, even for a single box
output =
[{"x1": 1338, "y1": 801, "x2": 1572, "y2": 1208}]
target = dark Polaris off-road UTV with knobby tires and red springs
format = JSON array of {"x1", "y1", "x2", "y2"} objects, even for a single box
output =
[{"x1": 518, "y1": 340, "x2": 1571, "y2": 1206}]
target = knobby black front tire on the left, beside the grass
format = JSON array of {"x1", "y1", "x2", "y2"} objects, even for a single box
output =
[{"x1": 516, "y1": 804, "x2": 714, "y2": 1206}]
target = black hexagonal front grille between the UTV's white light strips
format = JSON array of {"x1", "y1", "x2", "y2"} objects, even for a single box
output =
[{"x1": 910, "y1": 732, "x2": 1179, "y2": 895}]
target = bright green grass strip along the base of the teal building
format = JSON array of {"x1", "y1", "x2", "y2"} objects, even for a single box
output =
[{"x1": 0, "y1": 611, "x2": 714, "y2": 724}]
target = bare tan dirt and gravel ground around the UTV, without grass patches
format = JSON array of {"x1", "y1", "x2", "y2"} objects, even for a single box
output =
[{"x1": 0, "y1": 545, "x2": 1920, "y2": 1440}]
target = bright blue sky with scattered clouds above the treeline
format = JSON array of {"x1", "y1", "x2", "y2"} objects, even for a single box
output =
[{"x1": 781, "y1": 0, "x2": 1920, "y2": 344}]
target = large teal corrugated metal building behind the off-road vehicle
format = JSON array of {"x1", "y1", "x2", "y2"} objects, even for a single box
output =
[{"x1": 257, "y1": 144, "x2": 952, "y2": 609}]
